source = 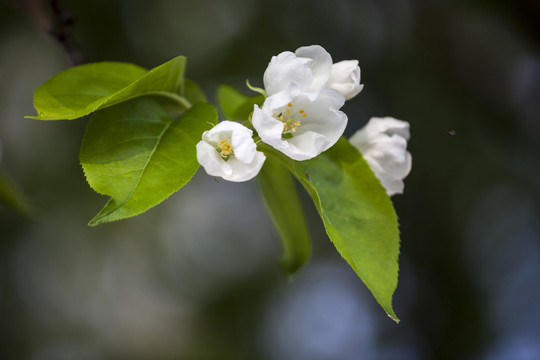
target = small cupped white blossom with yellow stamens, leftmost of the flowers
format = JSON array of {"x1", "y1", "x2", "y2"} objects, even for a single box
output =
[{"x1": 197, "y1": 121, "x2": 266, "y2": 182}]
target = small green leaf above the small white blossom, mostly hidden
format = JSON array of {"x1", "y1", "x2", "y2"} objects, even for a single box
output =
[{"x1": 217, "y1": 84, "x2": 265, "y2": 121}]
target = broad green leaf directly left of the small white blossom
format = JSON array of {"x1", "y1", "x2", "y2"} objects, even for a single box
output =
[{"x1": 80, "y1": 98, "x2": 217, "y2": 226}]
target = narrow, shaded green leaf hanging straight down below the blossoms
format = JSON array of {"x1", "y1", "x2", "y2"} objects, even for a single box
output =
[{"x1": 257, "y1": 156, "x2": 311, "y2": 276}]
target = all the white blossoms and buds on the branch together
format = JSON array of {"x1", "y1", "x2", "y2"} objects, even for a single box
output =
[{"x1": 197, "y1": 45, "x2": 411, "y2": 194}]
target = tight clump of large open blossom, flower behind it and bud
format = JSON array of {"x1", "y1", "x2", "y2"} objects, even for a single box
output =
[{"x1": 252, "y1": 45, "x2": 362, "y2": 160}]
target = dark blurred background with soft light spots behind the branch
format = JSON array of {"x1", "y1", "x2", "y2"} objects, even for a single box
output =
[{"x1": 0, "y1": 0, "x2": 540, "y2": 360}]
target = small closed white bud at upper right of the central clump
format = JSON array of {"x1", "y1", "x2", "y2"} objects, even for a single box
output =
[{"x1": 327, "y1": 60, "x2": 364, "y2": 100}]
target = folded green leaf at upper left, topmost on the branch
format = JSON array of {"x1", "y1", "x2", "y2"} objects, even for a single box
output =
[{"x1": 28, "y1": 56, "x2": 187, "y2": 120}]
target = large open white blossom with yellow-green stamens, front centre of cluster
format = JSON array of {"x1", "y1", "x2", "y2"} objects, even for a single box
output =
[{"x1": 252, "y1": 84, "x2": 347, "y2": 160}]
